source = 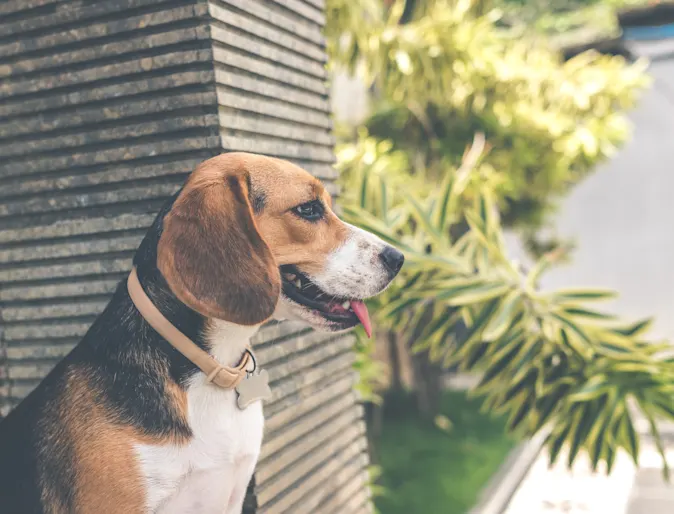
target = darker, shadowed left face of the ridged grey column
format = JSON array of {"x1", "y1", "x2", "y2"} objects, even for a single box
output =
[{"x1": 0, "y1": 0, "x2": 220, "y2": 412}]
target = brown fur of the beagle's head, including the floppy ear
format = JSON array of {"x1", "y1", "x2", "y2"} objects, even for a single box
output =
[{"x1": 157, "y1": 153, "x2": 347, "y2": 325}]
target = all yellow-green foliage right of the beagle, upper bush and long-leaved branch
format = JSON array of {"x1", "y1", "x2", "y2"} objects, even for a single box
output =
[{"x1": 328, "y1": 0, "x2": 674, "y2": 474}]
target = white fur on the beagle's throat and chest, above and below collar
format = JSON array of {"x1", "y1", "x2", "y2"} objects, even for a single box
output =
[{"x1": 136, "y1": 322, "x2": 264, "y2": 514}]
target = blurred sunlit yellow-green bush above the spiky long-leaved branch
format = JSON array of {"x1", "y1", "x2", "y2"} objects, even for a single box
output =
[{"x1": 327, "y1": 0, "x2": 647, "y2": 229}]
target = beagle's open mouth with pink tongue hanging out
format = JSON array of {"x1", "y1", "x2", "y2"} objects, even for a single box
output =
[{"x1": 281, "y1": 265, "x2": 372, "y2": 337}]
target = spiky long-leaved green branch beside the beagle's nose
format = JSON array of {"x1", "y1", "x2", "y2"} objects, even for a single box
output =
[{"x1": 339, "y1": 136, "x2": 674, "y2": 472}]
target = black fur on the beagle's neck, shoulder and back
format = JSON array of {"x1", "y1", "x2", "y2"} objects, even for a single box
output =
[{"x1": 0, "y1": 190, "x2": 213, "y2": 514}]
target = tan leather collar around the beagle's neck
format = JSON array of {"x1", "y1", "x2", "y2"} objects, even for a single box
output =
[{"x1": 126, "y1": 267, "x2": 254, "y2": 389}]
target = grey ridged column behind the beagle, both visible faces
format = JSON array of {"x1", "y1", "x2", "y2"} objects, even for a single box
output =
[{"x1": 0, "y1": 0, "x2": 370, "y2": 514}]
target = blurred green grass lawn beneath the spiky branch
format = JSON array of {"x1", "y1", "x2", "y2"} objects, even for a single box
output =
[{"x1": 375, "y1": 391, "x2": 515, "y2": 514}]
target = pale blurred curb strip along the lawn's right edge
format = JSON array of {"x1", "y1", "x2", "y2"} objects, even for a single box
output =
[{"x1": 468, "y1": 430, "x2": 548, "y2": 514}]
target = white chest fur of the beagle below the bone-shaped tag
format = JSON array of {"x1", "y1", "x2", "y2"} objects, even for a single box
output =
[{"x1": 137, "y1": 376, "x2": 264, "y2": 512}]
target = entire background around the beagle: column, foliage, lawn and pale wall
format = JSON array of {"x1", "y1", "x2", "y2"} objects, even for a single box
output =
[{"x1": 0, "y1": 0, "x2": 674, "y2": 514}]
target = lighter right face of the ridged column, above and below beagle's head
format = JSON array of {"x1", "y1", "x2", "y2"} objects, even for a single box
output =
[{"x1": 209, "y1": 0, "x2": 371, "y2": 508}]
